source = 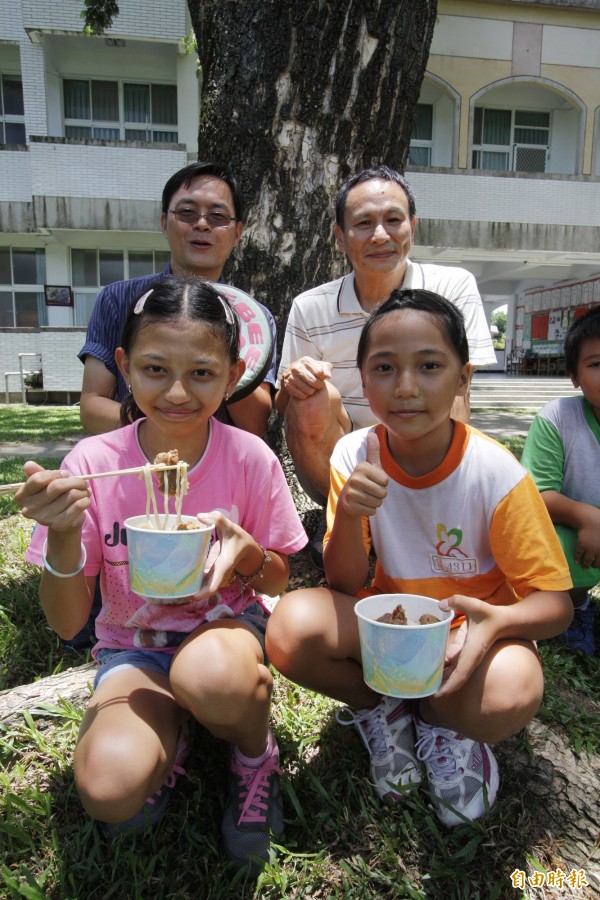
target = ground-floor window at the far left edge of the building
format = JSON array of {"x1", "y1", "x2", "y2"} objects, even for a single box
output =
[{"x1": 0, "y1": 247, "x2": 48, "y2": 328}]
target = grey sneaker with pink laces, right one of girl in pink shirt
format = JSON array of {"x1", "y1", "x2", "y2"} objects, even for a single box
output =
[{"x1": 221, "y1": 732, "x2": 283, "y2": 874}]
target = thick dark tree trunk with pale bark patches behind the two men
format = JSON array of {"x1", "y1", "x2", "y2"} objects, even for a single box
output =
[{"x1": 188, "y1": 0, "x2": 437, "y2": 340}]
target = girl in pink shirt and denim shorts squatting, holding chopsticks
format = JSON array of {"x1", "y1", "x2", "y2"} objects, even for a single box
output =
[{"x1": 16, "y1": 277, "x2": 306, "y2": 868}]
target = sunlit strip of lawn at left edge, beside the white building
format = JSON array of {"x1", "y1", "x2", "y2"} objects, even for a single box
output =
[{"x1": 0, "y1": 404, "x2": 84, "y2": 444}]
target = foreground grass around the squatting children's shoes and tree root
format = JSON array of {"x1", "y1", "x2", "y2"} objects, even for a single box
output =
[{"x1": 0, "y1": 410, "x2": 600, "y2": 900}]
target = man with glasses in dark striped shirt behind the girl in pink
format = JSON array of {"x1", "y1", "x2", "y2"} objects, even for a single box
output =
[{"x1": 78, "y1": 162, "x2": 276, "y2": 437}]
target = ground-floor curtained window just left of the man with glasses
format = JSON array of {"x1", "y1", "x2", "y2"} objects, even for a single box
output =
[{"x1": 71, "y1": 250, "x2": 171, "y2": 325}]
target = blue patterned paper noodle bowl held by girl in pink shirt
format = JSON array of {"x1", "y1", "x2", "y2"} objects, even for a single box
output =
[{"x1": 124, "y1": 514, "x2": 213, "y2": 603}]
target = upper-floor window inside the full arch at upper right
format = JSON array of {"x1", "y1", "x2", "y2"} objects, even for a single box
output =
[{"x1": 472, "y1": 107, "x2": 550, "y2": 172}]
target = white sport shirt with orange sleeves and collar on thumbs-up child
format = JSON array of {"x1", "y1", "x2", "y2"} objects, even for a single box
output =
[{"x1": 324, "y1": 422, "x2": 571, "y2": 605}]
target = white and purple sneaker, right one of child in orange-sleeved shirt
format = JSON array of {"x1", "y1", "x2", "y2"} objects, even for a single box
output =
[{"x1": 415, "y1": 720, "x2": 500, "y2": 828}]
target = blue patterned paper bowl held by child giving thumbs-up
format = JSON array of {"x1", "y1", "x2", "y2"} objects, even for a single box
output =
[{"x1": 354, "y1": 594, "x2": 453, "y2": 698}]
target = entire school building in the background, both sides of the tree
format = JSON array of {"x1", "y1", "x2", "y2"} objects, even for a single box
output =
[{"x1": 0, "y1": 0, "x2": 600, "y2": 400}]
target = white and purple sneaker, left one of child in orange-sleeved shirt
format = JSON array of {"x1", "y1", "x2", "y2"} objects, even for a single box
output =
[{"x1": 336, "y1": 697, "x2": 421, "y2": 802}]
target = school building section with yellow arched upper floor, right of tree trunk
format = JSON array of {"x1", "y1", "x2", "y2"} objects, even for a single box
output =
[{"x1": 407, "y1": 0, "x2": 600, "y2": 375}]
